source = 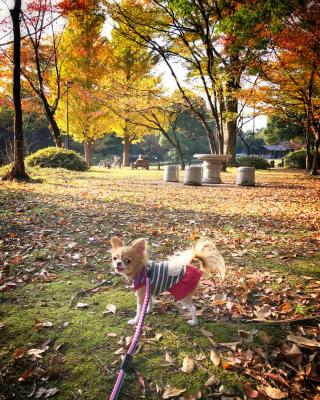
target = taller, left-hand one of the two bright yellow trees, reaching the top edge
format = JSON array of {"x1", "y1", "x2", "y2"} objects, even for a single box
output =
[{"x1": 57, "y1": 0, "x2": 110, "y2": 165}]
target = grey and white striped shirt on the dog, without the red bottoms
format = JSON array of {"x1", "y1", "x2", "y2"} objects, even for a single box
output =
[{"x1": 132, "y1": 261, "x2": 185, "y2": 295}]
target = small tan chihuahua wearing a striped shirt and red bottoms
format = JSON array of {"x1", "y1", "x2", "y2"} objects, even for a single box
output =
[{"x1": 111, "y1": 237, "x2": 226, "y2": 326}]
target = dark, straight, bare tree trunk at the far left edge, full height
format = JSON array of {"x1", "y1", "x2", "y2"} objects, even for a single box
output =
[{"x1": 3, "y1": 0, "x2": 30, "y2": 180}]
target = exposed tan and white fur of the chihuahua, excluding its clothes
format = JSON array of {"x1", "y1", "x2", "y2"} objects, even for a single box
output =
[{"x1": 111, "y1": 237, "x2": 226, "y2": 325}]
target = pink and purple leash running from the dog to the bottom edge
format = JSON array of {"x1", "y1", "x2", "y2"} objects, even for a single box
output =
[{"x1": 110, "y1": 271, "x2": 151, "y2": 400}]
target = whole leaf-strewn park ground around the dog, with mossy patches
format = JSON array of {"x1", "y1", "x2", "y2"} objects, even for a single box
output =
[{"x1": 0, "y1": 168, "x2": 320, "y2": 400}]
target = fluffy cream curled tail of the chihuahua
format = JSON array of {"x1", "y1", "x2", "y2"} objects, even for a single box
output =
[{"x1": 192, "y1": 238, "x2": 226, "y2": 281}]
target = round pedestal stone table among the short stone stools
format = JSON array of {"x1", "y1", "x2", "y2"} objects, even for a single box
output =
[{"x1": 194, "y1": 154, "x2": 232, "y2": 183}]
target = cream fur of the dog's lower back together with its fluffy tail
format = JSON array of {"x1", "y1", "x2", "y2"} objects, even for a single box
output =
[{"x1": 168, "y1": 238, "x2": 226, "y2": 280}]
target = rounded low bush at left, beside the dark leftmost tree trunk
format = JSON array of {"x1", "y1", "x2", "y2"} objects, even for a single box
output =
[{"x1": 25, "y1": 147, "x2": 88, "y2": 171}]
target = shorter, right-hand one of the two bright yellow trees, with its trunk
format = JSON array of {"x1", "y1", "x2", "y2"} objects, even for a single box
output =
[{"x1": 105, "y1": 26, "x2": 161, "y2": 165}]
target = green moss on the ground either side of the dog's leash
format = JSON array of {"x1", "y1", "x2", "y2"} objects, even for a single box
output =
[{"x1": 0, "y1": 273, "x2": 250, "y2": 399}]
